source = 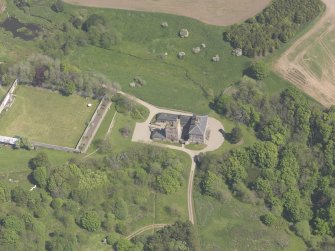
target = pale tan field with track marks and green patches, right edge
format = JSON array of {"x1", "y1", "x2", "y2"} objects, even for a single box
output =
[{"x1": 275, "y1": 0, "x2": 335, "y2": 107}]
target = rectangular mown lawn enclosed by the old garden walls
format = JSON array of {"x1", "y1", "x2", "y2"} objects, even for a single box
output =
[{"x1": 0, "y1": 86, "x2": 98, "y2": 147}]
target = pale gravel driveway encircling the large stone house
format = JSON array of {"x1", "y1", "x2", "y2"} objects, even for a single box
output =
[{"x1": 119, "y1": 91, "x2": 224, "y2": 224}]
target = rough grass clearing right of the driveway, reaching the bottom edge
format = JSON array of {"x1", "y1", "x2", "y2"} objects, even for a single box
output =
[{"x1": 194, "y1": 189, "x2": 306, "y2": 251}]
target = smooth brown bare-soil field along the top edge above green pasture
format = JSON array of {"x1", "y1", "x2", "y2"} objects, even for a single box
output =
[{"x1": 64, "y1": 0, "x2": 271, "y2": 26}]
